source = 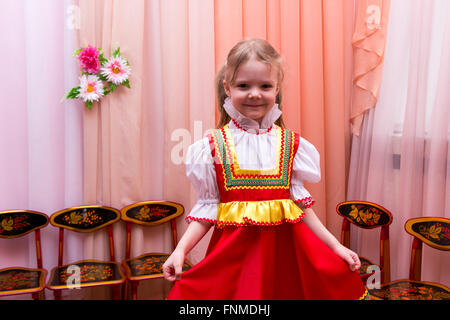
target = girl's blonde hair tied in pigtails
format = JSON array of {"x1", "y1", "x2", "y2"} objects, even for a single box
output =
[{"x1": 215, "y1": 39, "x2": 284, "y2": 128}]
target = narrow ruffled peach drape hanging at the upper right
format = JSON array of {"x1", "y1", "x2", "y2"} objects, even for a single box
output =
[{"x1": 351, "y1": 0, "x2": 390, "y2": 136}]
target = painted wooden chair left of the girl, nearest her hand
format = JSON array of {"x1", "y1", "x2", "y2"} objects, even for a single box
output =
[{"x1": 121, "y1": 201, "x2": 192, "y2": 300}]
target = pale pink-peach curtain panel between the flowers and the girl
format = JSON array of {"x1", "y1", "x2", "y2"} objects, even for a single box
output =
[{"x1": 79, "y1": 0, "x2": 214, "y2": 298}]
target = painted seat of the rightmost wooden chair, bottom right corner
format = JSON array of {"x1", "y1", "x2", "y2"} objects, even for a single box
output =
[{"x1": 369, "y1": 280, "x2": 450, "y2": 300}]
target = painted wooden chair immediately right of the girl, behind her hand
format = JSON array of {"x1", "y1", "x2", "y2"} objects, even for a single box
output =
[{"x1": 336, "y1": 201, "x2": 393, "y2": 283}]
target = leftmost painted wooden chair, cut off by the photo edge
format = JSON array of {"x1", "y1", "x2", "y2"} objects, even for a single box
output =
[{"x1": 0, "y1": 210, "x2": 48, "y2": 300}]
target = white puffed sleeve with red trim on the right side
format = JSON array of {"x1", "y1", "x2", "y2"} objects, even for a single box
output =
[{"x1": 290, "y1": 137, "x2": 320, "y2": 209}]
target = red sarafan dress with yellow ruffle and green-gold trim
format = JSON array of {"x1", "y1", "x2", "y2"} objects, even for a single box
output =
[{"x1": 168, "y1": 125, "x2": 368, "y2": 300}]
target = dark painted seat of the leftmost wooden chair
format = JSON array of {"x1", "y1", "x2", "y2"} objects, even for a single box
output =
[{"x1": 0, "y1": 267, "x2": 47, "y2": 296}]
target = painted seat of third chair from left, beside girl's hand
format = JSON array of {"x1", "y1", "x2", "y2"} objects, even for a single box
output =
[{"x1": 123, "y1": 252, "x2": 192, "y2": 280}]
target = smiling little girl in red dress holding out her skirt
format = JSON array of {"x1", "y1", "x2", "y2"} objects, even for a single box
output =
[{"x1": 163, "y1": 39, "x2": 368, "y2": 300}]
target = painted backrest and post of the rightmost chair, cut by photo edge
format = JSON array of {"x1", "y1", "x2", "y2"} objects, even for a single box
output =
[{"x1": 405, "y1": 217, "x2": 450, "y2": 281}]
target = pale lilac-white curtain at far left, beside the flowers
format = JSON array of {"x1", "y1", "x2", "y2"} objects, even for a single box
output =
[{"x1": 0, "y1": 0, "x2": 83, "y2": 299}]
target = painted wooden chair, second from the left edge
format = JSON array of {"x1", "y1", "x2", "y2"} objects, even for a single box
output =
[{"x1": 47, "y1": 205, "x2": 125, "y2": 300}]
